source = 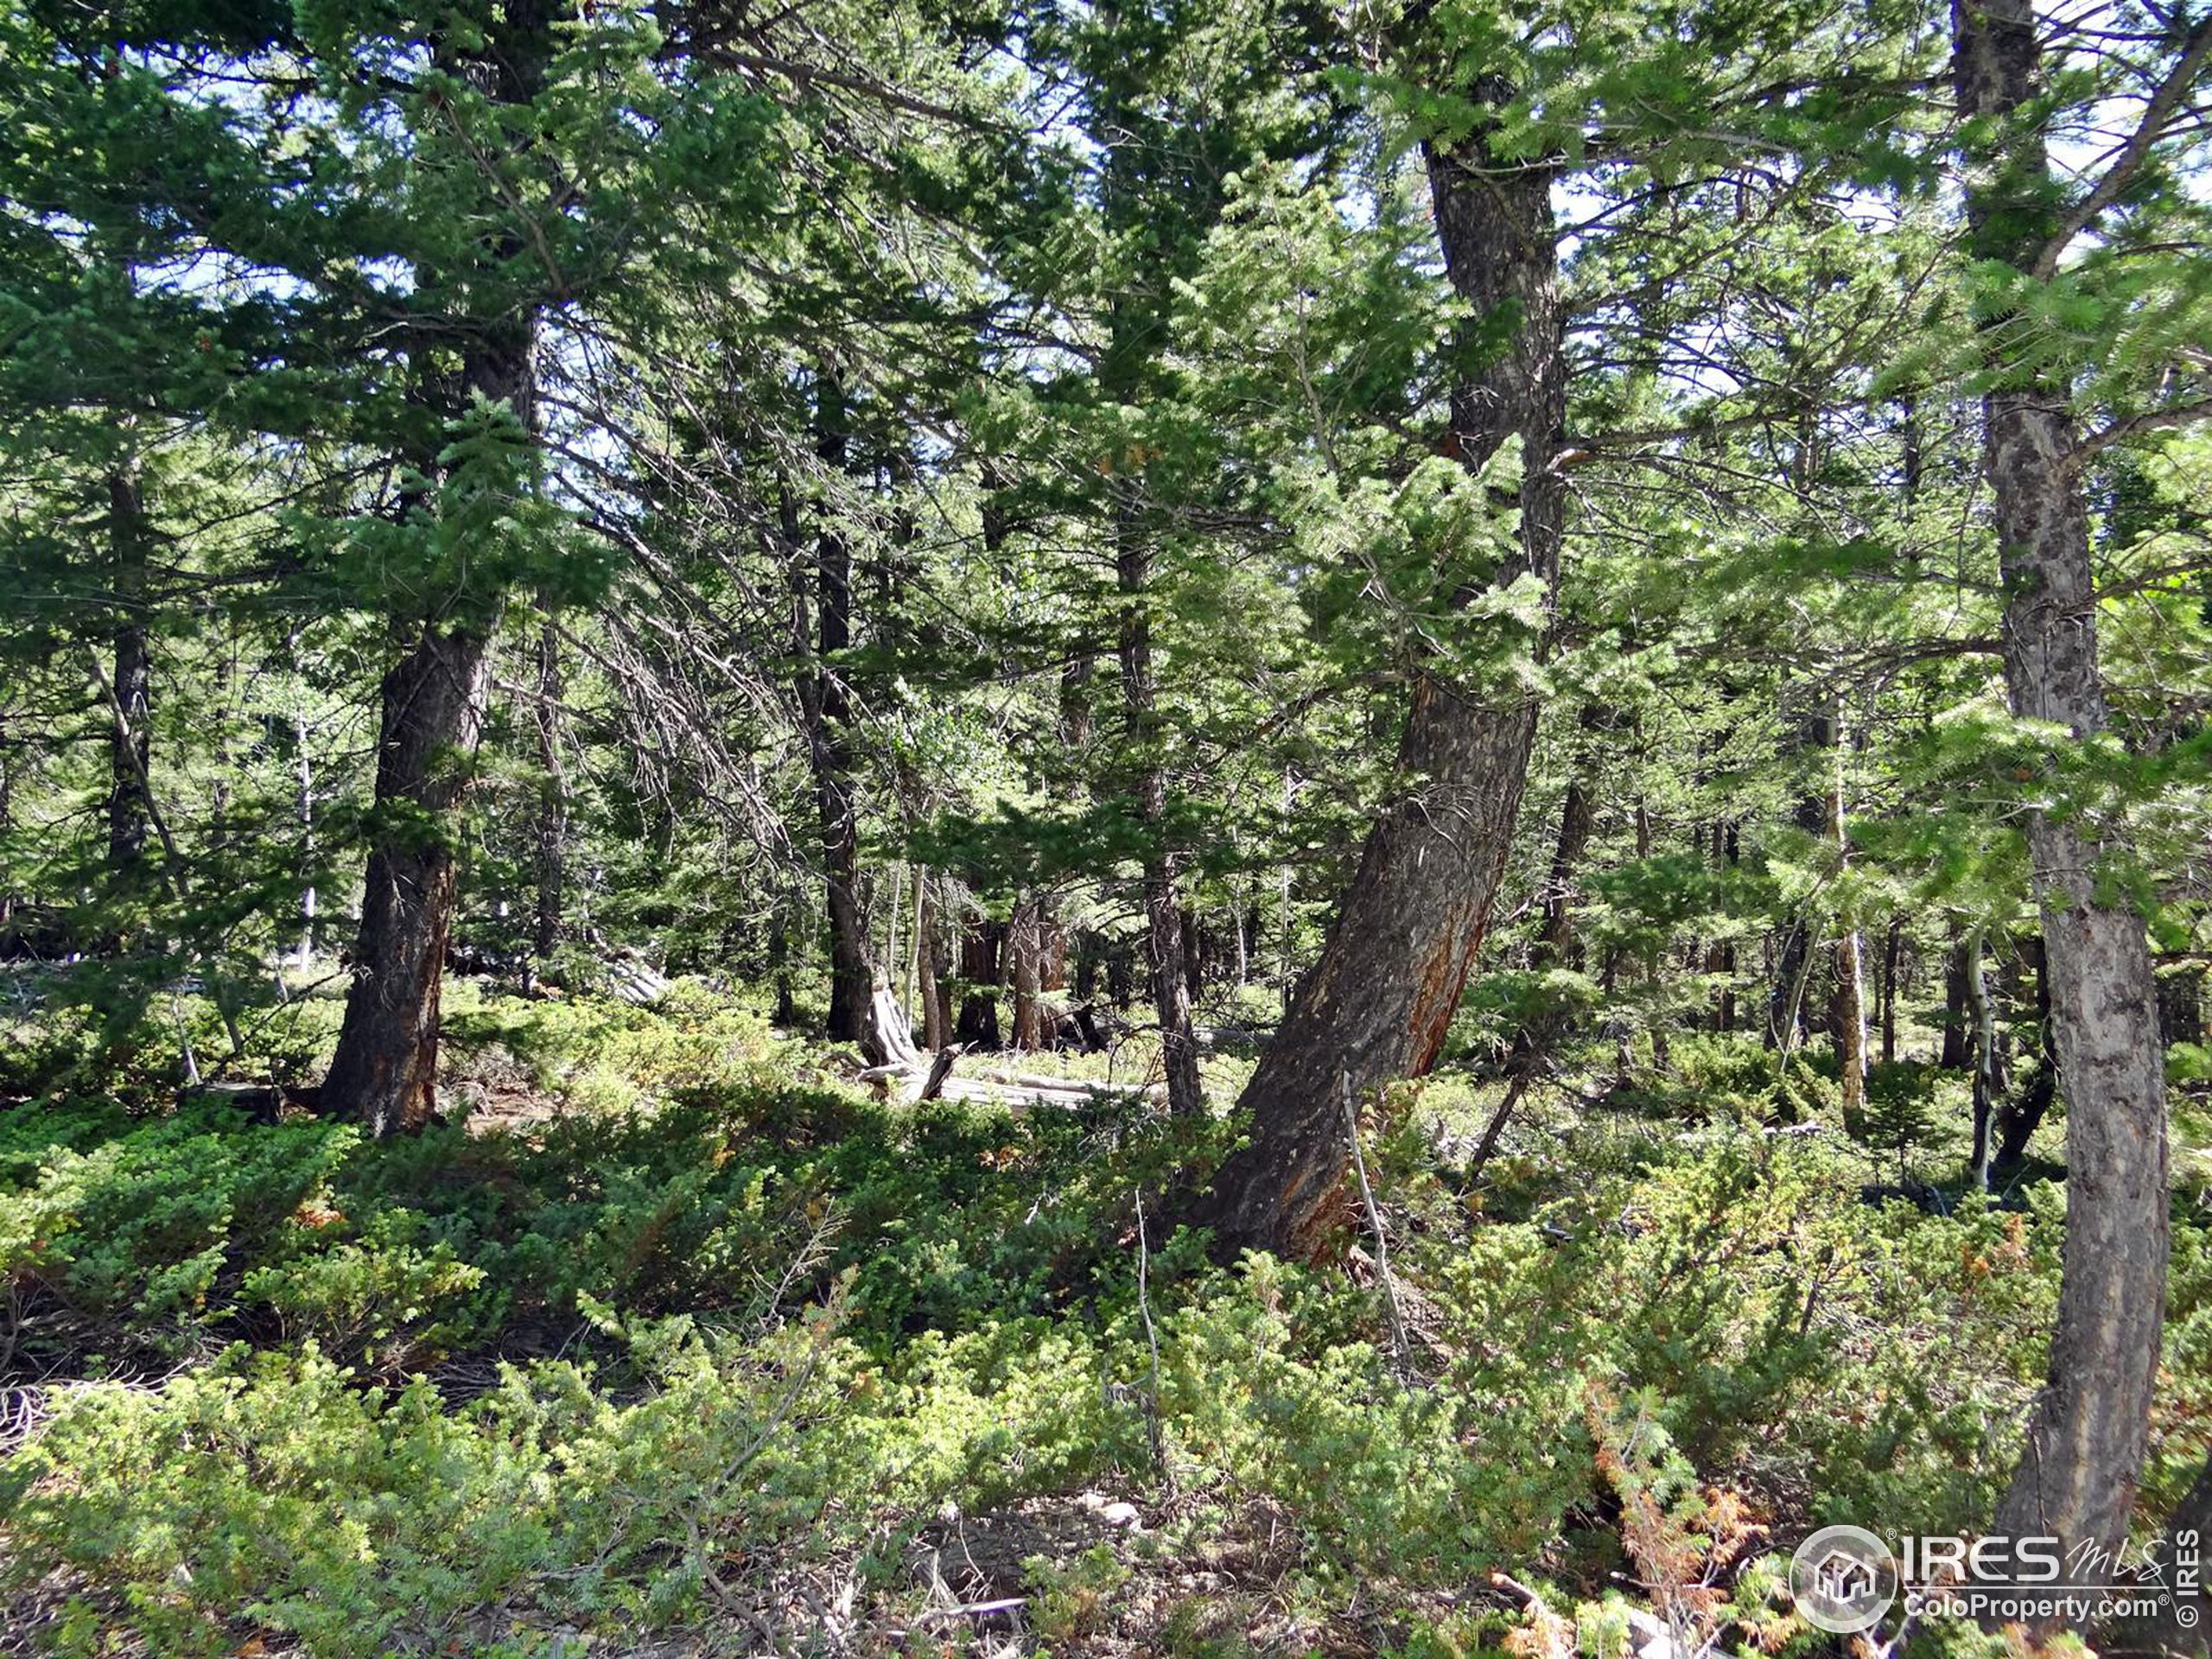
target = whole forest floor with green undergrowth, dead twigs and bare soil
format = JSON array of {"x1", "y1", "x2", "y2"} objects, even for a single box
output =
[{"x1": 0, "y1": 984, "x2": 2212, "y2": 1659}]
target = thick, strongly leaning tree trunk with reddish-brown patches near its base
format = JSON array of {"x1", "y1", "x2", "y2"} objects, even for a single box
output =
[{"x1": 1188, "y1": 100, "x2": 1566, "y2": 1256}]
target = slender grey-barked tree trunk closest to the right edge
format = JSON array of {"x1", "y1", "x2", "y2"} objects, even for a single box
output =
[{"x1": 1953, "y1": 0, "x2": 2168, "y2": 1592}]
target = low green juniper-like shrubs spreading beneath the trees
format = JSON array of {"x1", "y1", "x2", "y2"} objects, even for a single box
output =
[{"x1": 0, "y1": 993, "x2": 2123, "y2": 1655}]
